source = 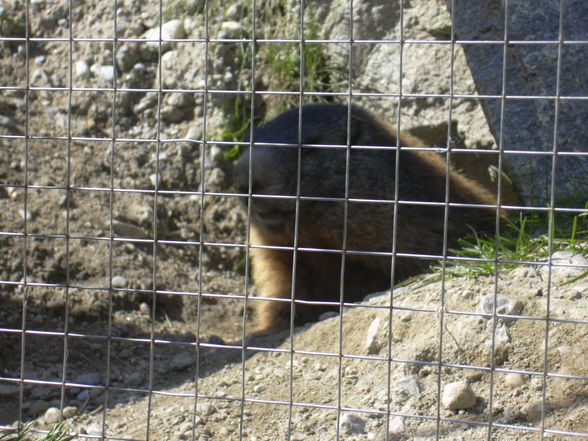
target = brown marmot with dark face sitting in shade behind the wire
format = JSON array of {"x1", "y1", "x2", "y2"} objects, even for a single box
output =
[{"x1": 234, "y1": 104, "x2": 496, "y2": 334}]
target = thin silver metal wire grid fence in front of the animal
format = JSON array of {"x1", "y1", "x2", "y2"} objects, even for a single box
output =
[{"x1": 0, "y1": 0, "x2": 588, "y2": 440}]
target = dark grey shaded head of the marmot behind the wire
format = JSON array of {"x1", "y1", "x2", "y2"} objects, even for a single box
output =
[{"x1": 234, "y1": 104, "x2": 369, "y2": 227}]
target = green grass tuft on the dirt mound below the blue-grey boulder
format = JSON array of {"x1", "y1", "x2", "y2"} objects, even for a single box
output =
[{"x1": 432, "y1": 203, "x2": 588, "y2": 278}]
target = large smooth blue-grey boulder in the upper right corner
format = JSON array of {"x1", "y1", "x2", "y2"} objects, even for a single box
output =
[{"x1": 446, "y1": 0, "x2": 588, "y2": 206}]
